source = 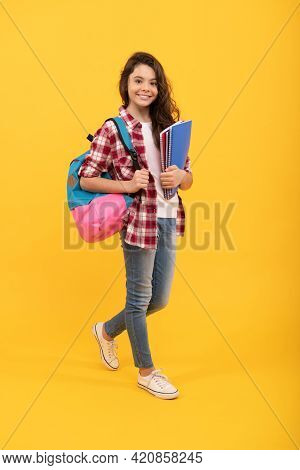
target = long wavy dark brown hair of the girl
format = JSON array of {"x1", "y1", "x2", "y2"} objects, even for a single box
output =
[{"x1": 119, "y1": 52, "x2": 180, "y2": 149}]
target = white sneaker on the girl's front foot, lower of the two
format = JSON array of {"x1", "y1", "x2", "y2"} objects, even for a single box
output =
[{"x1": 138, "y1": 369, "x2": 179, "y2": 400}]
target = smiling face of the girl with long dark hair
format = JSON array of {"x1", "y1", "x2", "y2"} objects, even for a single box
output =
[{"x1": 128, "y1": 64, "x2": 158, "y2": 108}]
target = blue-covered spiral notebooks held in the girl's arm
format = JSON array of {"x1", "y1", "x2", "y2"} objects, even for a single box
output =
[{"x1": 160, "y1": 120, "x2": 192, "y2": 199}]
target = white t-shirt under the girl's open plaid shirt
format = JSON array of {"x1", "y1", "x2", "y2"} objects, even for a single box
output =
[{"x1": 141, "y1": 122, "x2": 179, "y2": 218}]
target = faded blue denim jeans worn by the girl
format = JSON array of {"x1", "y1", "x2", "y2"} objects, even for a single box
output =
[{"x1": 104, "y1": 217, "x2": 176, "y2": 368}]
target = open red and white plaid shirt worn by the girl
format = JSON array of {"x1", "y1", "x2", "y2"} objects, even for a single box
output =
[{"x1": 78, "y1": 106, "x2": 192, "y2": 248}]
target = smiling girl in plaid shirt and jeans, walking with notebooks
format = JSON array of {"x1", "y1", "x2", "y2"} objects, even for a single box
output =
[{"x1": 78, "y1": 52, "x2": 193, "y2": 399}]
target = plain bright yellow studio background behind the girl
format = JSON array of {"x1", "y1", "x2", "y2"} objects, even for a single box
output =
[{"x1": 0, "y1": 0, "x2": 300, "y2": 449}]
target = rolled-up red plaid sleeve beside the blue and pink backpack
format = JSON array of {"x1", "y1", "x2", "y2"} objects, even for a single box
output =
[{"x1": 78, "y1": 125, "x2": 111, "y2": 178}]
